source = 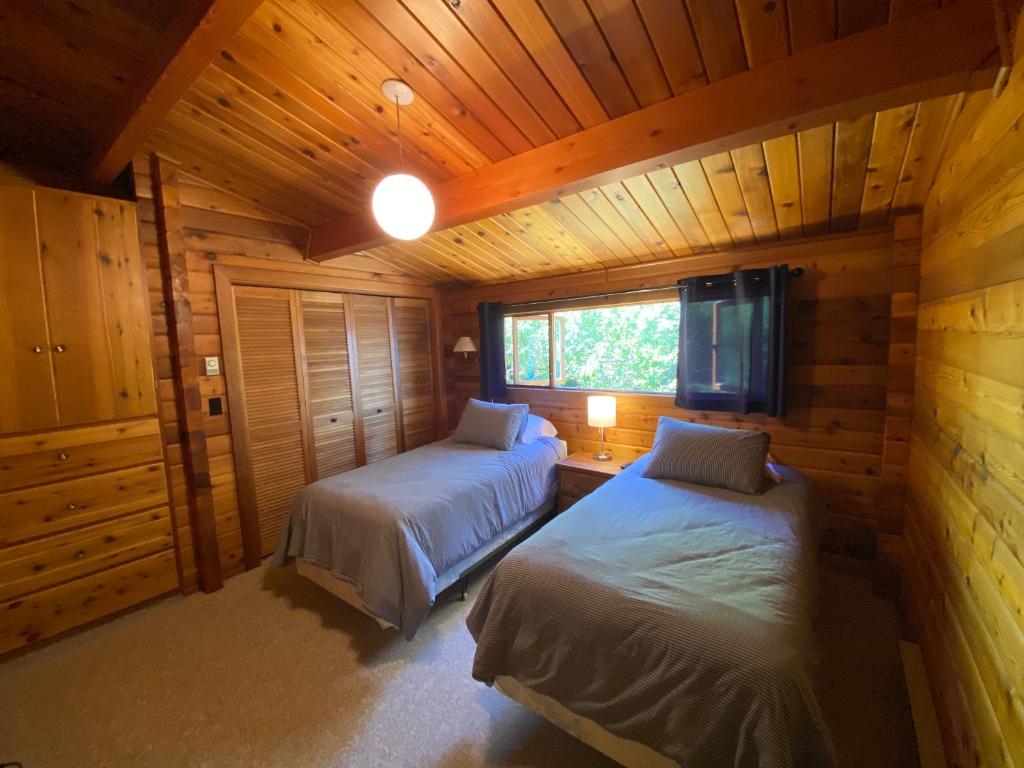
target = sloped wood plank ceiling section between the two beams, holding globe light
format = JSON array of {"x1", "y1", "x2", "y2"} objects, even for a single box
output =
[{"x1": 140, "y1": 0, "x2": 962, "y2": 226}]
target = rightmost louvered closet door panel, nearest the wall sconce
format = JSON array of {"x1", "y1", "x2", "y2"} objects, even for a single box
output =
[{"x1": 392, "y1": 298, "x2": 437, "y2": 451}]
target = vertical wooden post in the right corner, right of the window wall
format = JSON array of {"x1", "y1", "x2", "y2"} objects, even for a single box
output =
[{"x1": 876, "y1": 214, "x2": 921, "y2": 595}]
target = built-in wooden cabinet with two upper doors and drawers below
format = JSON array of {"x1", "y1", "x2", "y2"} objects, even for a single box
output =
[{"x1": 0, "y1": 187, "x2": 178, "y2": 653}]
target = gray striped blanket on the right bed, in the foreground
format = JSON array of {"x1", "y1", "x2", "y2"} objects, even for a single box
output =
[{"x1": 467, "y1": 458, "x2": 836, "y2": 768}]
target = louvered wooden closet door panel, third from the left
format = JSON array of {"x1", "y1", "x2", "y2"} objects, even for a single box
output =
[{"x1": 349, "y1": 294, "x2": 399, "y2": 464}]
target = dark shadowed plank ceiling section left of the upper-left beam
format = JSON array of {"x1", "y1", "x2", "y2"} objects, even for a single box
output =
[{"x1": 0, "y1": 0, "x2": 210, "y2": 184}]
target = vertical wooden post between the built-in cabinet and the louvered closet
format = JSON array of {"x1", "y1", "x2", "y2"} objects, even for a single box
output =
[{"x1": 151, "y1": 155, "x2": 223, "y2": 592}]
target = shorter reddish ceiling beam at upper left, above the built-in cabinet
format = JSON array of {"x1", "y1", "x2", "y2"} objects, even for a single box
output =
[{"x1": 88, "y1": 0, "x2": 262, "y2": 184}]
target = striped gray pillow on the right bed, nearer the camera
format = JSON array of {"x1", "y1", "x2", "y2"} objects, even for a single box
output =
[{"x1": 643, "y1": 416, "x2": 771, "y2": 494}]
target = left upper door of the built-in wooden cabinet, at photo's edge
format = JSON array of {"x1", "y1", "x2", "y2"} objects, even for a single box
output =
[{"x1": 0, "y1": 186, "x2": 57, "y2": 432}]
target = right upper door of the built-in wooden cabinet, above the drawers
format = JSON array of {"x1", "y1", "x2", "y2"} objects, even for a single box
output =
[{"x1": 36, "y1": 189, "x2": 157, "y2": 425}]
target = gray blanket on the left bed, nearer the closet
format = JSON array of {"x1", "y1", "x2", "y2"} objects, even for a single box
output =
[{"x1": 273, "y1": 437, "x2": 564, "y2": 639}]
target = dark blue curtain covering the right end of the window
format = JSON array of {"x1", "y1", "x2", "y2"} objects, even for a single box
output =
[{"x1": 676, "y1": 265, "x2": 790, "y2": 416}]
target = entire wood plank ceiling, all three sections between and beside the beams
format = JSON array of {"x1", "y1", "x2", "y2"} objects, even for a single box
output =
[{"x1": 0, "y1": 0, "x2": 986, "y2": 282}]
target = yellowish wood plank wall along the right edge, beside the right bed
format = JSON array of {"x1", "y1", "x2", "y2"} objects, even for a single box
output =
[{"x1": 903, "y1": 46, "x2": 1024, "y2": 765}]
